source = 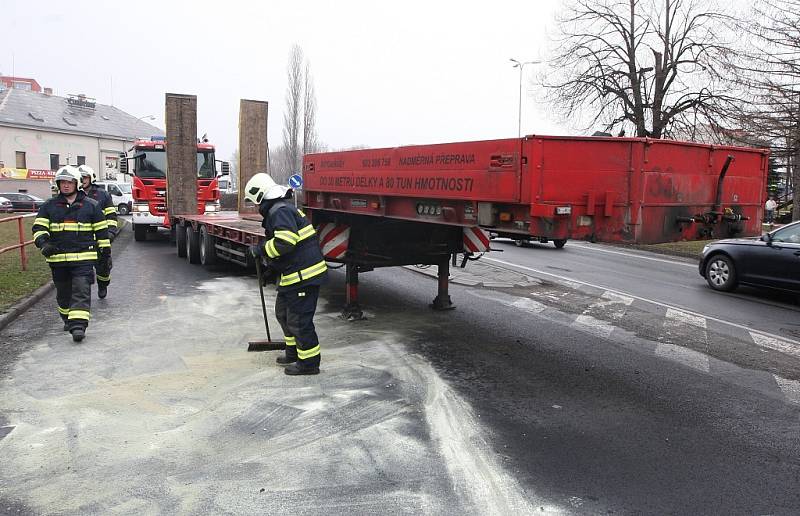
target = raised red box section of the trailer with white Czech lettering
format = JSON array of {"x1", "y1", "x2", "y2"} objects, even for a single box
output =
[{"x1": 303, "y1": 136, "x2": 768, "y2": 247}]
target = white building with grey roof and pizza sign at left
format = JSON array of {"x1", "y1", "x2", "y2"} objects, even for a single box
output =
[{"x1": 0, "y1": 86, "x2": 164, "y2": 198}]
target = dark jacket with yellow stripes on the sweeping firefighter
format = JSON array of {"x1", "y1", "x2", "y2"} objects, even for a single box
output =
[{"x1": 259, "y1": 200, "x2": 328, "y2": 291}]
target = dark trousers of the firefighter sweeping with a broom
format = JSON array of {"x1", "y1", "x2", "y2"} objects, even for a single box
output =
[{"x1": 275, "y1": 285, "x2": 320, "y2": 368}]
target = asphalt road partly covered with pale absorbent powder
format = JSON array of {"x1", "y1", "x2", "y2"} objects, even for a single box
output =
[{"x1": 0, "y1": 231, "x2": 800, "y2": 514}]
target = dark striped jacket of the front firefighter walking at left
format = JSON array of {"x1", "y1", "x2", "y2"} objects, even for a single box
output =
[{"x1": 31, "y1": 190, "x2": 111, "y2": 267}]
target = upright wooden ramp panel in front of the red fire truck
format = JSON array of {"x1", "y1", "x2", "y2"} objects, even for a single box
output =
[{"x1": 166, "y1": 93, "x2": 197, "y2": 216}]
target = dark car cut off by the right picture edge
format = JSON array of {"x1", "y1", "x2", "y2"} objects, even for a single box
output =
[{"x1": 700, "y1": 221, "x2": 800, "y2": 292}]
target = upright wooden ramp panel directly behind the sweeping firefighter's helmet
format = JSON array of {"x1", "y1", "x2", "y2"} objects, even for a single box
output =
[{"x1": 238, "y1": 99, "x2": 269, "y2": 213}]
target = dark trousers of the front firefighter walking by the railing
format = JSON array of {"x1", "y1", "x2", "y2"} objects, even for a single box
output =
[{"x1": 51, "y1": 265, "x2": 94, "y2": 331}]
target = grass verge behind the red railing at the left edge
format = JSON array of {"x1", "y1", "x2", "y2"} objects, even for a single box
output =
[{"x1": 0, "y1": 214, "x2": 51, "y2": 313}]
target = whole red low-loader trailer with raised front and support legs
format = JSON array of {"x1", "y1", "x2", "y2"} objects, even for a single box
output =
[{"x1": 173, "y1": 136, "x2": 768, "y2": 317}]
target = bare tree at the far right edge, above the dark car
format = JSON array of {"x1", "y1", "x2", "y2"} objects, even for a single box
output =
[{"x1": 734, "y1": 0, "x2": 800, "y2": 220}]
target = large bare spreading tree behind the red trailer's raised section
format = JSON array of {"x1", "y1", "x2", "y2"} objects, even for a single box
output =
[{"x1": 541, "y1": 0, "x2": 733, "y2": 138}]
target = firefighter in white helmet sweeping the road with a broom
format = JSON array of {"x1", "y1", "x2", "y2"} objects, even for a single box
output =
[{"x1": 245, "y1": 173, "x2": 328, "y2": 375}]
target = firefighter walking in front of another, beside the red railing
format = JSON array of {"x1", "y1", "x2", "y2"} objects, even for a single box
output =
[{"x1": 32, "y1": 165, "x2": 111, "y2": 342}]
